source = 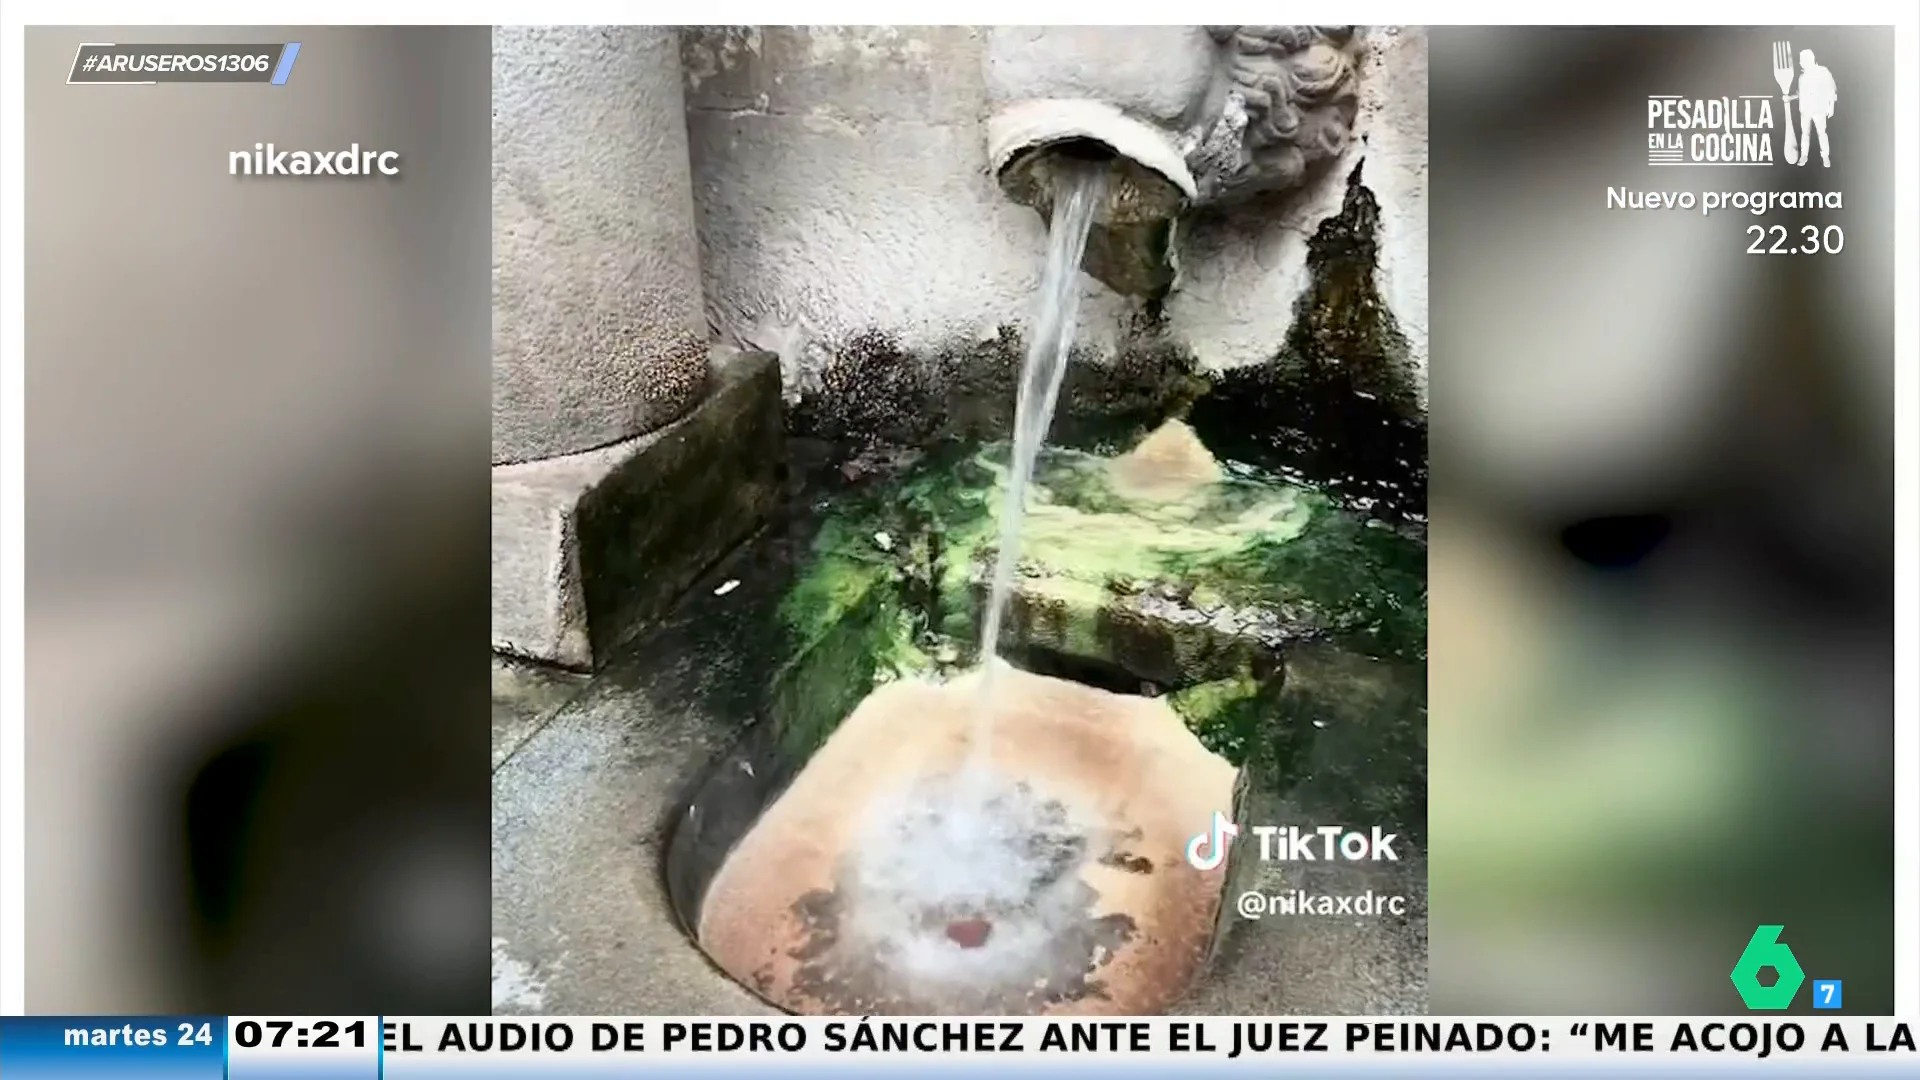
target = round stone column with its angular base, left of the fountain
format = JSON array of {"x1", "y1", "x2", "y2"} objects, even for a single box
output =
[{"x1": 493, "y1": 27, "x2": 780, "y2": 669}]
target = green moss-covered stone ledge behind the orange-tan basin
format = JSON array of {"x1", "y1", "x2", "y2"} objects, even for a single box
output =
[{"x1": 774, "y1": 418, "x2": 1427, "y2": 776}]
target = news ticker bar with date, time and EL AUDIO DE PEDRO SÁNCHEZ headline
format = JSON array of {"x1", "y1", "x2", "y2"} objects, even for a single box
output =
[{"x1": 0, "y1": 1017, "x2": 1920, "y2": 1080}]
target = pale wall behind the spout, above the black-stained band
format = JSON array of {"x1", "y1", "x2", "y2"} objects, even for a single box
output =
[{"x1": 682, "y1": 27, "x2": 1427, "y2": 407}]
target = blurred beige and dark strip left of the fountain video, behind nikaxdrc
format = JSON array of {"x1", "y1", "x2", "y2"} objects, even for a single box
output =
[{"x1": 25, "y1": 27, "x2": 492, "y2": 1013}]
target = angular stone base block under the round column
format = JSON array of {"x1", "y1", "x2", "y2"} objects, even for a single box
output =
[{"x1": 493, "y1": 352, "x2": 783, "y2": 669}]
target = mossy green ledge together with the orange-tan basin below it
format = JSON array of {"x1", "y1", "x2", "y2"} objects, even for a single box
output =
[{"x1": 664, "y1": 425, "x2": 1425, "y2": 1015}]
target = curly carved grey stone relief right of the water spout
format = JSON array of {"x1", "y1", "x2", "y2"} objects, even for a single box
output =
[{"x1": 1181, "y1": 27, "x2": 1361, "y2": 206}]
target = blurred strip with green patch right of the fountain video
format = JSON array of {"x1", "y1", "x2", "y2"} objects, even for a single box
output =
[{"x1": 1428, "y1": 27, "x2": 1895, "y2": 1015}]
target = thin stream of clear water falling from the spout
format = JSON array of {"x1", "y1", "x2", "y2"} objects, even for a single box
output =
[{"x1": 973, "y1": 160, "x2": 1108, "y2": 745}]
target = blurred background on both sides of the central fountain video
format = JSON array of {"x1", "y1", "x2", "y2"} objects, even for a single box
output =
[{"x1": 11, "y1": 27, "x2": 1893, "y2": 1013}]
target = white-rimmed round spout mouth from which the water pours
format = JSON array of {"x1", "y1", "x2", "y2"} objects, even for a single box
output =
[{"x1": 987, "y1": 100, "x2": 1198, "y2": 300}]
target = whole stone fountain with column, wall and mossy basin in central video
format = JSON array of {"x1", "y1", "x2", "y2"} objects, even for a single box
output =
[{"x1": 495, "y1": 27, "x2": 1425, "y2": 1013}]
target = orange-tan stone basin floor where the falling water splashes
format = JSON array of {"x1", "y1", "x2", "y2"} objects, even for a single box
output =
[{"x1": 697, "y1": 669, "x2": 1236, "y2": 1015}]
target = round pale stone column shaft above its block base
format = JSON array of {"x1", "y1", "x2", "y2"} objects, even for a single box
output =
[{"x1": 493, "y1": 27, "x2": 707, "y2": 457}]
